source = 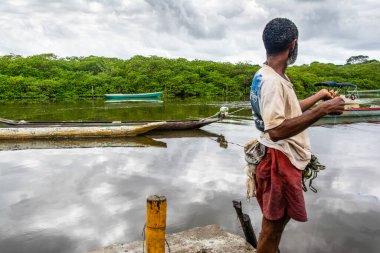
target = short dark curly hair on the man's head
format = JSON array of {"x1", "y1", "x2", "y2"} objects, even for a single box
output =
[{"x1": 263, "y1": 18, "x2": 298, "y2": 55}]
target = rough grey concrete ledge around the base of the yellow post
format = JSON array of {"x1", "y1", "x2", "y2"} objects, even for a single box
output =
[{"x1": 90, "y1": 225, "x2": 256, "y2": 253}]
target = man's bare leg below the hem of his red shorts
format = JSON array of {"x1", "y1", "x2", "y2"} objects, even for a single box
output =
[{"x1": 256, "y1": 216, "x2": 290, "y2": 253}]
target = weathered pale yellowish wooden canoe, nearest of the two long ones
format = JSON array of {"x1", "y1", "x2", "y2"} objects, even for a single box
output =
[{"x1": 0, "y1": 122, "x2": 166, "y2": 139}]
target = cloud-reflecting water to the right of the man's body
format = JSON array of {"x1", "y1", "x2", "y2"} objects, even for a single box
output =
[{"x1": 282, "y1": 124, "x2": 380, "y2": 252}]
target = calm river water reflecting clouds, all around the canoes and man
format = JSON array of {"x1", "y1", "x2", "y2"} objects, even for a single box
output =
[{"x1": 0, "y1": 100, "x2": 380, "y2": 253}]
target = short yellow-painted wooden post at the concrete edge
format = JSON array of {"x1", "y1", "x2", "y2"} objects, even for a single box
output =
[{"x1": 145, "y1": 195, "x2": 166, "y2": 253}]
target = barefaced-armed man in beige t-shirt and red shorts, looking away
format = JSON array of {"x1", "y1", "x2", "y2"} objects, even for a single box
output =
[{"x1": 251, "y1": 18, "x2": 344, "y2": 253}]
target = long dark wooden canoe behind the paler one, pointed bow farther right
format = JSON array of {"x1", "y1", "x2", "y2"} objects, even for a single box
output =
[{"x1": 0, "y1": 118, "x2": 221, "y2": 131}]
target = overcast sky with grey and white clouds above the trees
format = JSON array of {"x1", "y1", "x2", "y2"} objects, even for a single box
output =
[{"x1": 0, "y1": 0, "x2": 380, "y2": 64}]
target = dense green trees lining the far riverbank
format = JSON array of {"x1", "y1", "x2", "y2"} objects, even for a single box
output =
[{"x1": 0, "y1": 54, "x2": 380, "y2": 100}]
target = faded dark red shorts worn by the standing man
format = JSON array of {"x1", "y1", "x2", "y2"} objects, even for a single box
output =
[{"x1": 256, "y1": 148, "x2": 307, "y2": 222}]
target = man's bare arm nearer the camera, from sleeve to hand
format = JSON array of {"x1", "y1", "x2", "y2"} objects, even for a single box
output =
[{"x1": 268, "y1": 97, "x2": 344, "y2": 141}]
